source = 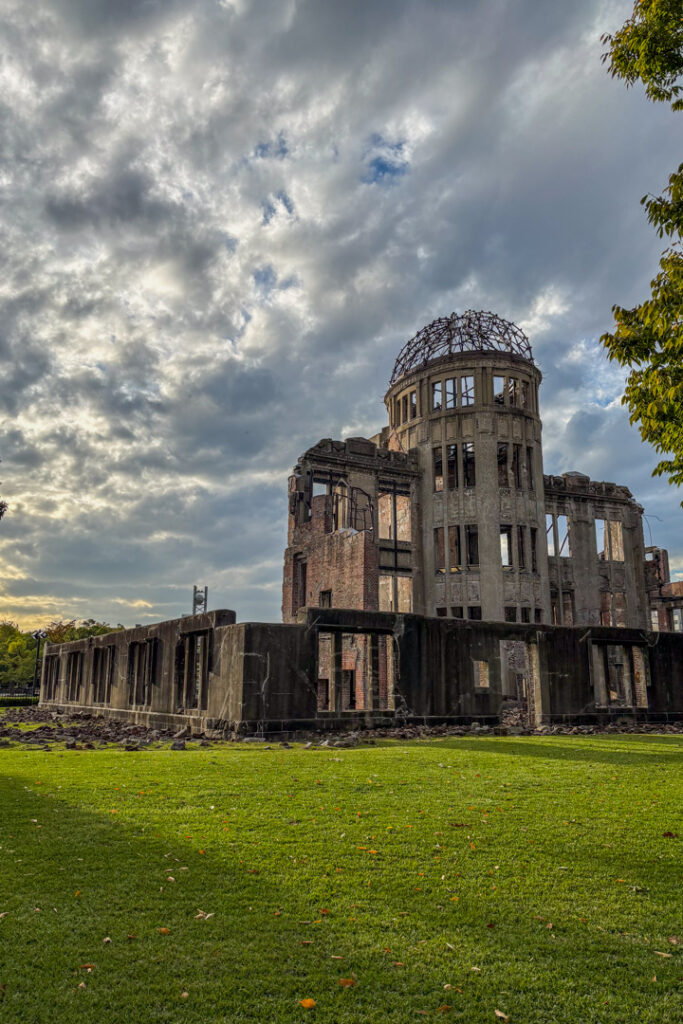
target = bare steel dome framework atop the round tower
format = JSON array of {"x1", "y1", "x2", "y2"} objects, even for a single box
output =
[{"x1": 389, "y1": 309, "x2": 533, "y2": 387}]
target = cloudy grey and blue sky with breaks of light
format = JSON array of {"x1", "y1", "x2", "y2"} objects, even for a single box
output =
[{"x1": 0, "y1": 0, "x2": 683, "y2": 626}]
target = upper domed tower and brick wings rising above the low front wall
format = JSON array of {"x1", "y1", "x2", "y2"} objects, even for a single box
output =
[{"x1": 283, "y1": 310, "x2": 649, "y2": 628}]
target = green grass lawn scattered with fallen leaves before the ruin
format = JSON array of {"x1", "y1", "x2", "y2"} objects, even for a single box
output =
[{"x1": 0, "y1": 735, "x2": 683, "y2": 1024}]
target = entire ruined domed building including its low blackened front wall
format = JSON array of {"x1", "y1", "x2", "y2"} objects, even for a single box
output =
[{"x1": 41, "y1": 311, "x2": 683, "y2": 735}]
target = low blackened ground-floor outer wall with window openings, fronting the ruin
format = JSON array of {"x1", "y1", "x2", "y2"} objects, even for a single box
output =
[{"x1": 41, "y1": 608, "x2": 683, "y2": 735}]
